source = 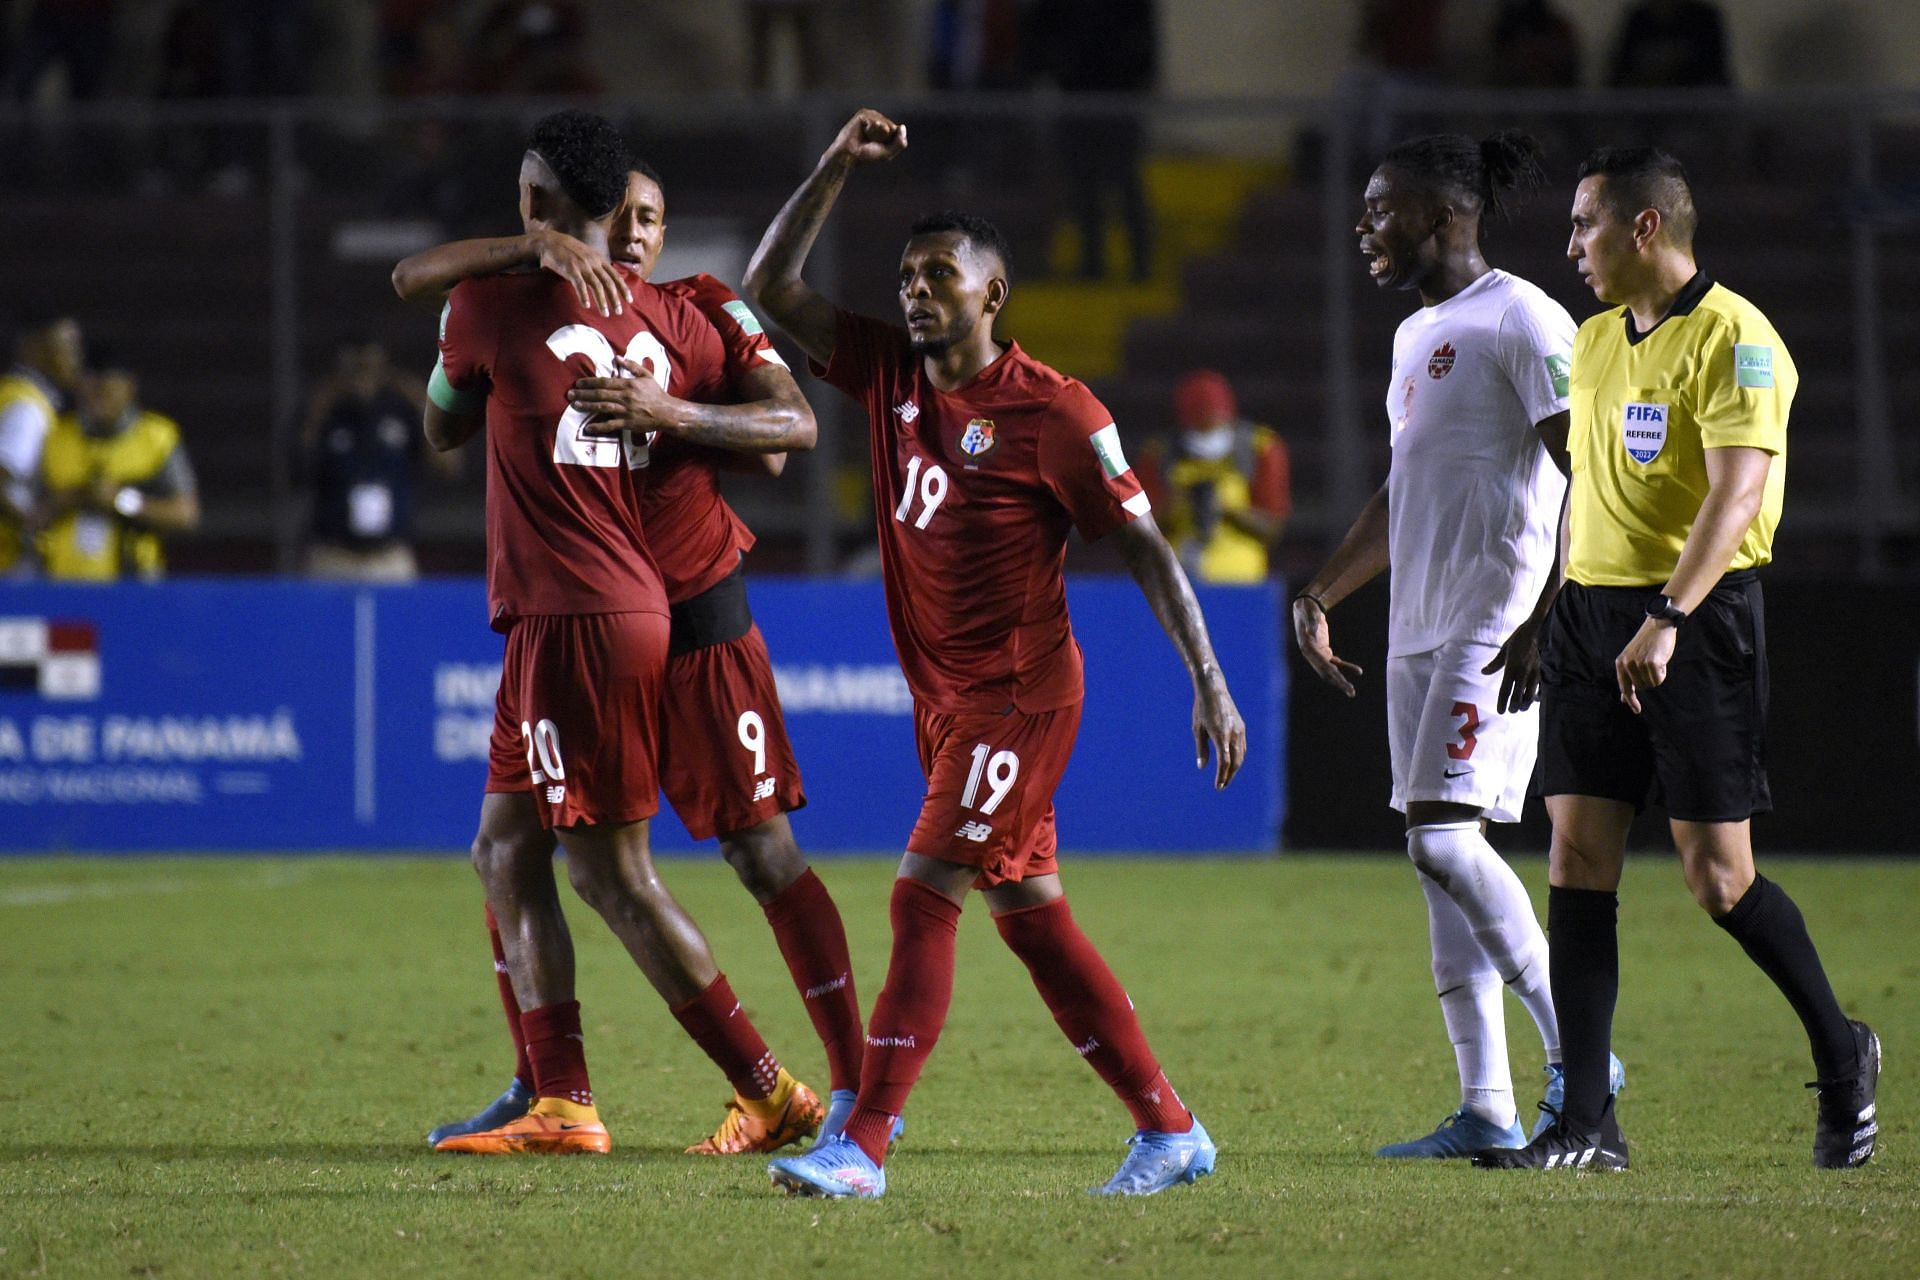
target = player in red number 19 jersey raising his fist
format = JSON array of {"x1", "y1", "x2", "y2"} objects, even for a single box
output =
[{"x1": 747, "y1": 111, "x2": 1246, "y2": 1196}]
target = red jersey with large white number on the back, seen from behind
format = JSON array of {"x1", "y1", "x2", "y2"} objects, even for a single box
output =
[{"x1": 440, "y1": 271, "x2": 726, "y2": 631}]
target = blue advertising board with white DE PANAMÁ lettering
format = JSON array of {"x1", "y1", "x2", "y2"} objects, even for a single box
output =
[{"x1": 0, "y1": 578, "x2": 1286, "y2": 852}]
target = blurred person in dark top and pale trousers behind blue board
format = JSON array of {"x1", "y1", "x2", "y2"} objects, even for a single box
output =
[{"x1": 301, "y1": 342, "x2": 459, "y2": 581}]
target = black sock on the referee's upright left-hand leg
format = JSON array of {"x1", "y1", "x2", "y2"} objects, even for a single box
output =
[{"x1": 1548, "y1": 885, "x2": 1620, "y2": 1132}]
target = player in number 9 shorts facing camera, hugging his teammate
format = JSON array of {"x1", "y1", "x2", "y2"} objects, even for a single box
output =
[{"x1": 394, "y1": 165, "x2": 862, "y2": 1155}]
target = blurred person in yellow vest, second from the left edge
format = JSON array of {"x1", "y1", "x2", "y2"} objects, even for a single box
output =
[{"x1": 36, "y1": 355, "x2": 200, "y2": 581}]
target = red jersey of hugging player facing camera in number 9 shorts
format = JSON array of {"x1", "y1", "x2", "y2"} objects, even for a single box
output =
[{"x1": 639, "y1": 274, "x2": 785, "y2": 604}]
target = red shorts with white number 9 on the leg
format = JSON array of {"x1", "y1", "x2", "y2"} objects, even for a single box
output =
[{"x1": 660, "y1": 628, "x2": 806, "y2": 841}]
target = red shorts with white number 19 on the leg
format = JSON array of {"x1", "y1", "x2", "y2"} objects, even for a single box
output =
[{"x1": 906, "y1": 702, "x2": 1081, "y2": 889}]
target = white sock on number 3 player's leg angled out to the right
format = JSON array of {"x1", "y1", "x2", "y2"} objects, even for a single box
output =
[{"x1": 1407, "y1": 821, "x2": 1561, "y2": 1105}]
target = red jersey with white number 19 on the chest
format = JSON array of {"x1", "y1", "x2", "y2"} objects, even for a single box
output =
[{"x1": 820, "y1": 311, "x2": 1148, "y2": 714}]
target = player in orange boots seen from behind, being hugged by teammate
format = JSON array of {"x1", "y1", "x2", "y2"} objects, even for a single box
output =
[{"x1": 426, "y1": 111, "x2": 820, "y2": 1153}]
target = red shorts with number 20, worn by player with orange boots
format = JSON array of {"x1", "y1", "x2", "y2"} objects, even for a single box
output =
[{"x1": 486, "y1": 614, "x2": 666, "y2": 827}]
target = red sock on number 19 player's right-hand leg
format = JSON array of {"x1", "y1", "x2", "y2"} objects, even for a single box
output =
[{"x1": 998, "y1": 898, "x2": 1194, "y2": 1134}]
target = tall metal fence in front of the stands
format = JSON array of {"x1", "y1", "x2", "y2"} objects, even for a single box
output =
[{"x1": 0, "y1": 84, "x2": 1920, "y2": 578}]
